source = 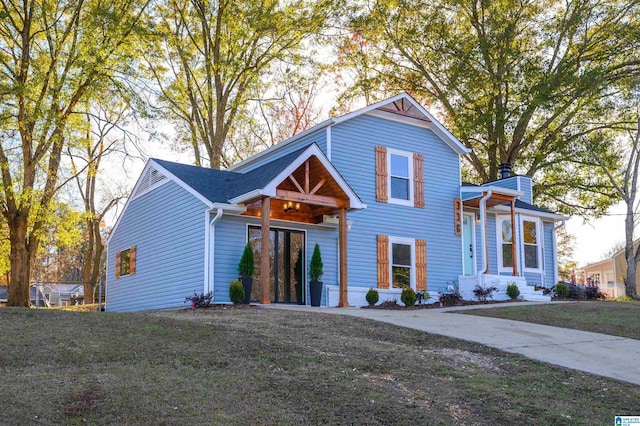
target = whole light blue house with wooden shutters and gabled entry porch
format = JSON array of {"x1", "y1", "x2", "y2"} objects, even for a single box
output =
[{"x1": 106, "y1": 94, "x2": 565, "y2": 311}]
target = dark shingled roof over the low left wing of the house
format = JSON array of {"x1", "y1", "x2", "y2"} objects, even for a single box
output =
[{"x1": 153, "y1": 145, "x2": 309, "y2": 203}]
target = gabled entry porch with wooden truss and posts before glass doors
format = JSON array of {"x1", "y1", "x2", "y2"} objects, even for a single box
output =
[{"x1": 229, "y1": 144, "x2": 366, "y2": 306}]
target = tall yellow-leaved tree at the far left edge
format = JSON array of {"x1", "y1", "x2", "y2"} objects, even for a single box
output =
[{"x1": 0, "y1": 0, "x2": 146, "y2": 306}]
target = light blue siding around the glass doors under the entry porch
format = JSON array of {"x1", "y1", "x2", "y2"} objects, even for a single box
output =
[{"x1": 214, "y1": 216, "x2": 338, "y2": 306}]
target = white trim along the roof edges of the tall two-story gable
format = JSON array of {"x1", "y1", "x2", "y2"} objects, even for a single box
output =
[{"x1": 227, "y1": 92, "x2": 471, "y2": 171}]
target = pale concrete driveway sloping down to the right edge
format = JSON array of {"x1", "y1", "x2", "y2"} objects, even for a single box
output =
[{"x1": 271, "y1": 302, "x2": 640, "y2": 385}]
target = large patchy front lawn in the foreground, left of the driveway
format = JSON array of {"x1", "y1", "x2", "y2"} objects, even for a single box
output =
[{"x1": 0, "y1": 308, "x2": 640, "y2": 425}]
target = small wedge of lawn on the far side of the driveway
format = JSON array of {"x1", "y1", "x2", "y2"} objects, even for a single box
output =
[{"x1": 458, "y1": 301, "x2": 640, "y2": 339}]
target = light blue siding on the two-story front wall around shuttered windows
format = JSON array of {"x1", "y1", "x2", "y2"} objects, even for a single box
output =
[{"x1": 331, "y1": 115, "x2": 462, "y2": 291}]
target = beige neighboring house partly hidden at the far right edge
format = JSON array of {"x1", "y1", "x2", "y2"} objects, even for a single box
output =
[{"x1": 580, "y1": 240, "x2": 640, "y2": 298}]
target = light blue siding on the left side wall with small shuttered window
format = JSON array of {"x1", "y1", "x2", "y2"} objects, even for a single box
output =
[{"x1": 106, "y1": 182, "x2": 206, "y2": 312}]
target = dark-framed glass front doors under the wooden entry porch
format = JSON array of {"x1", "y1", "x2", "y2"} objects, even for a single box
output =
[{"x1": 249, "y1": 226, "x2": 305, "y2": 304}]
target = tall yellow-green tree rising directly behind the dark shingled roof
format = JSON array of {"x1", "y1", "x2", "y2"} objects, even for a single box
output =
[{"x1": 145, "y1": 0, "x2": 337, "y2": 169}]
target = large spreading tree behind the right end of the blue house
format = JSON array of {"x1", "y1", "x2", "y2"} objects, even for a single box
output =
[{"x1": 338, "y1": 0, "x2": 640, "y2": 214}]
